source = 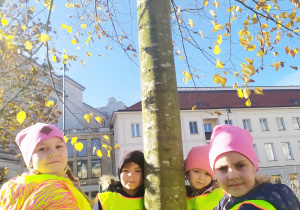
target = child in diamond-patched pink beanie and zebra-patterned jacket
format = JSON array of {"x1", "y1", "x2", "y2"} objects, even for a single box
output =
[{"x1": 0, "y1": 123, "x2": 91, "y2": 210}]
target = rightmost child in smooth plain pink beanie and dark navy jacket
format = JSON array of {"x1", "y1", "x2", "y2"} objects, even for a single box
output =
[{"x1": 209, "y1": 125, "x2": 300, "y2": 210}]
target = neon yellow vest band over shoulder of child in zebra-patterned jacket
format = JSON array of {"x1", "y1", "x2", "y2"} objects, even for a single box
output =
[{"x1": 16, "y1": 174, "x2": 91, "y2": 210}]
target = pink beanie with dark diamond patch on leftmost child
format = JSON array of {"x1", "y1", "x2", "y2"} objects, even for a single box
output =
[{"x1": 16, "y1": 123, "x2": 65, "y2": 168}]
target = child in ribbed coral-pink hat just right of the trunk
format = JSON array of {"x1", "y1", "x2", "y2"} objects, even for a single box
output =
[{"x1": 184, "y1": 145, "x2": 224, "y2": 210}]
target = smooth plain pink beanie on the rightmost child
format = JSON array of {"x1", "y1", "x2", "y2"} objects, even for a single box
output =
[{"x1": 209, "y1": 125, "x2": 258, "y2": 171}]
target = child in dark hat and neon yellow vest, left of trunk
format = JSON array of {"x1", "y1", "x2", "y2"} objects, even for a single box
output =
[{"x1": 93, "y1": 150, "x2": 145, "y2": 210}]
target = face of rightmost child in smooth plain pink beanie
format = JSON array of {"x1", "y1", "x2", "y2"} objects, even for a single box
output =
[{"x1": 215, "y1": 152, "x2": 256, "y2": 197}]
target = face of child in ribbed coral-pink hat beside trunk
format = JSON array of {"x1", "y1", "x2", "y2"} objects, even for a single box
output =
[{"x1": 187, "y1": 168, "x2": 212, "y2": 190}]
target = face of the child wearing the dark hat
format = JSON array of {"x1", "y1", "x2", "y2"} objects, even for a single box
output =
[{"x1": 120, "y1": 162, "x2": 143, "y2": 195}]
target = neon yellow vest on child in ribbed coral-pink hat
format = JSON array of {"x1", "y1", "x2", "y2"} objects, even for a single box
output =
[{"x1": 186, "y1": 188, "x2": 224, "y2": 210}]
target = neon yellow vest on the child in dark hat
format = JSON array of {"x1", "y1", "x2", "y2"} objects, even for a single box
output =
[{"x1": 98, "y1": 192, "x2": 144, "y2": 210}]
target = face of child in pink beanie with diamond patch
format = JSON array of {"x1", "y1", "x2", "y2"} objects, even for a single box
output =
[{"x1": 31, "y1": 137, "x2": 68, "y2": 176}]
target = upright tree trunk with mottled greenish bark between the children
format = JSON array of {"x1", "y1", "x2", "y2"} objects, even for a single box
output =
[{"x1": 137, "y1": 0, "x2": 186, "y2": 210}]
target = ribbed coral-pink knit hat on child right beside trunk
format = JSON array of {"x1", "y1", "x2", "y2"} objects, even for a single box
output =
[{"x1": 184, "y1": 144, "x2": 215, "y2": 179}]
